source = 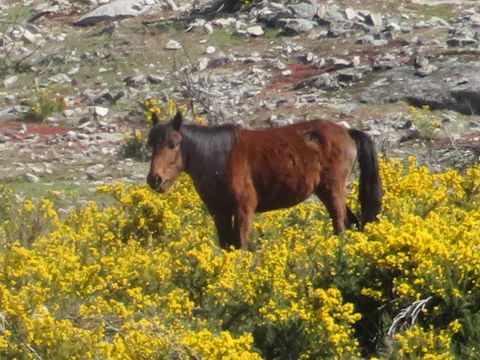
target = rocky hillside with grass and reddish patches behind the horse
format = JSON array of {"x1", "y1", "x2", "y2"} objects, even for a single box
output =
[{"x1": 0, "y1": 0, "x2": 480, "y2": 191}]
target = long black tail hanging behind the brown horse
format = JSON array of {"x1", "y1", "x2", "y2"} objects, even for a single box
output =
[{"x1": 348, "y1": 129, "x2": 383, "y2": 227}]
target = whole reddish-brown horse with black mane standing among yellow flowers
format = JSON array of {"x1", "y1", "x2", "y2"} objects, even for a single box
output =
[{"x1": 147, "y1": 112, "x2": 382, "y2": 249}]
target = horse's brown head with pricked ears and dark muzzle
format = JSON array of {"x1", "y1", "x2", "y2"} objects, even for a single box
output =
[{"x1": 147, "y1": 111, "x2": 184, "y2": 192}]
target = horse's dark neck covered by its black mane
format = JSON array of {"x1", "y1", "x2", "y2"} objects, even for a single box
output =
[{"x1": 182, "y1": 125, "x2": 235, "y2": 185}]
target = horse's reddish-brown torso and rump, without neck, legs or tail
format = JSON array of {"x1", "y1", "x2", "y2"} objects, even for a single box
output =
[{"x1": 231, "y1": 120, "x2": 356, "y2": 211}]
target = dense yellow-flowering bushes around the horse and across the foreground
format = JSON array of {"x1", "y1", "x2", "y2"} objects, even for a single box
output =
[{"x1": 0, "y1": 159, "x2": 480, "y2": 360}]
